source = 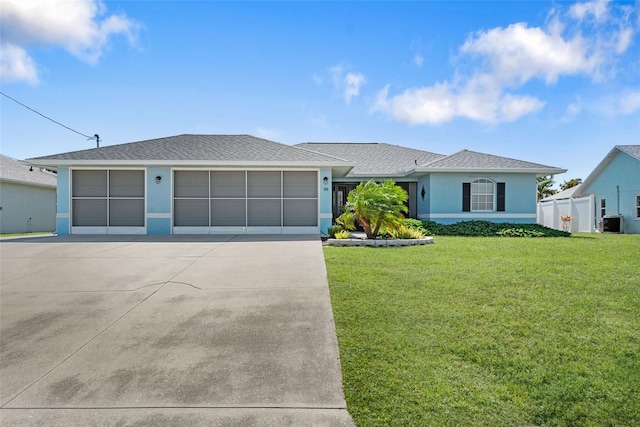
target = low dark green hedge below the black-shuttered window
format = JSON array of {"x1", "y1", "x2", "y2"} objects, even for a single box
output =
[{"x1": 422, "y1": 221, "x2": 571, "y2": 237}]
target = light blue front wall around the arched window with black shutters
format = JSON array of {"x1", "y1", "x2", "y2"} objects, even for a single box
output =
[{"x1": 418, "y1": 173, "x2": 536, "y2": 224}]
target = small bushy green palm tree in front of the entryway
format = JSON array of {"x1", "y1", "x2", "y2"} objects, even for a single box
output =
[{"x1": 336, "y1": 180, "x2": 408, "y2": 239}]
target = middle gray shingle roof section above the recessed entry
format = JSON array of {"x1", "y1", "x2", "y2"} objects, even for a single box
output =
[{"x1": 295, "y1": 142, "x2": 444, "y2": 176}]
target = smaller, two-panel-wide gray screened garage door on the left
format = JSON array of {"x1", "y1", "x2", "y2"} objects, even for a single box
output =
[{"x1": 71, "y1": 169, "x2": 145, "y2": 233}]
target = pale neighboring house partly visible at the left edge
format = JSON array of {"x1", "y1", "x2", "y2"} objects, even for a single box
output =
[{"x1": 0, "y1": 155, "x2": 56, "y2": 233}]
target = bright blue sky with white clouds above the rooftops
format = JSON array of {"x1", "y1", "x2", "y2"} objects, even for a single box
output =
[{"x1": 0, "y1": 0, "x2": 640, "y2": 182}]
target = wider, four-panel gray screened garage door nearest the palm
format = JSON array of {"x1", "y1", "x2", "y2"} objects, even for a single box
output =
[{"x1": 173, "y1": 170, "x2": 318, "y2": 233}]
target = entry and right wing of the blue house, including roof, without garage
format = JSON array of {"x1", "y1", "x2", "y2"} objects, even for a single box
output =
[{"x1": 296, "y1": 143, "x2": 566, "y2": 223}]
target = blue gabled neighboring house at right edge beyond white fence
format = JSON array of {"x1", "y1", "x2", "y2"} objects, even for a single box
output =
[{"x1": 573, "y1": 145, "x2": 640, "y2": 234}]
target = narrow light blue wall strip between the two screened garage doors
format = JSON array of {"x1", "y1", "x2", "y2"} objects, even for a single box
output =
[{"x1": 147, "y1": 167, "x2": 173, "y2": 235}]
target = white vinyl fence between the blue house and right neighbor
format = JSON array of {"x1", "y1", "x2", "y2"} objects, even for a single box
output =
[{"x1": 537, "y1": 194, "x2": 596, "y2": 233}]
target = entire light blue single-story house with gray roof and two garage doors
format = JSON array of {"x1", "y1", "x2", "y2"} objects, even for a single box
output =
[{"x1": 30, "y1": 135, "x2": 565, "y2": 234}]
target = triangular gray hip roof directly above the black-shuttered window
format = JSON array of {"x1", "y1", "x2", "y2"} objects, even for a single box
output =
[{"x1": 424, "y1": 150, "x2": 558, "y2": 170}]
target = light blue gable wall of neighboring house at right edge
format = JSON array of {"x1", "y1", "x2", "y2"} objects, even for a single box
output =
[{"x1": 580, "y1": 151, "x2": 640, "y2": 234}]
